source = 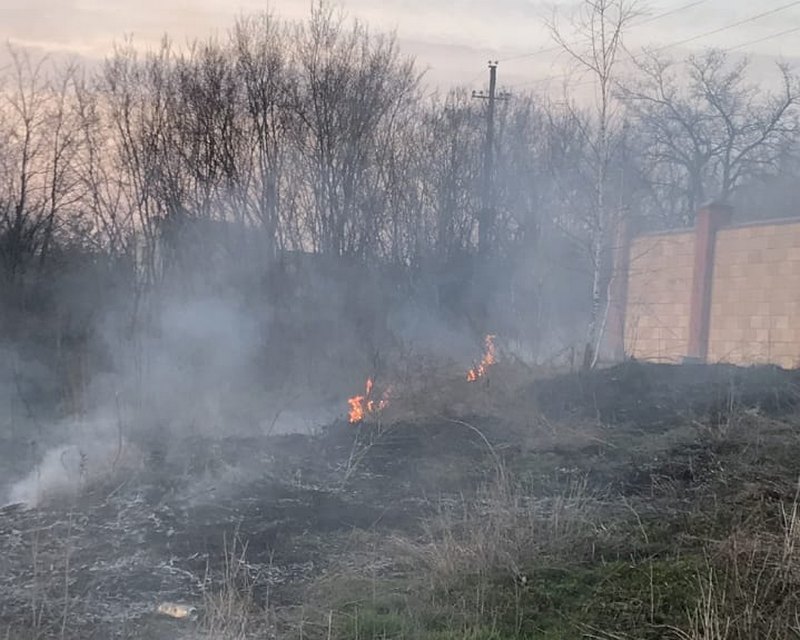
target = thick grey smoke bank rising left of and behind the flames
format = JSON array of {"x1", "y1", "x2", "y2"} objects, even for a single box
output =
[{"x1": 0, "y1": 242, "x2": 544, "y2": 507}]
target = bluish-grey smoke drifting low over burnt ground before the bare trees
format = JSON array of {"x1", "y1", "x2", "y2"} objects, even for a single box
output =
[{"x1": 0, "y1": 195, "x2": 588, "y2": 506}]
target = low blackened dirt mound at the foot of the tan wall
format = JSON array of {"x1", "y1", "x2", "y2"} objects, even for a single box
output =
[{"x1": 525, "y1": 361, "x2": 800, "y2": 427}]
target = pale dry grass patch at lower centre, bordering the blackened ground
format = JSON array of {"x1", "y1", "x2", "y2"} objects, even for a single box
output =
[{"x1": 291, "y1": 468, "x2": 612, "y2": 640}]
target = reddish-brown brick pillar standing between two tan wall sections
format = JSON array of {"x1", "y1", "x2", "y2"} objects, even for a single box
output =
[{"x1": 687, "y1": 202, "x2": 733, "y2": 362}]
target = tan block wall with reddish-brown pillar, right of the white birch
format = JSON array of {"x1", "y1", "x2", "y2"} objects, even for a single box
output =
[{"x1": 614, "y1": 207, "x2": 800, "y2": 368}]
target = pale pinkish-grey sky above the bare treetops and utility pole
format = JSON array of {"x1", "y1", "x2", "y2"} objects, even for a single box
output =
[{"x1": 0, "y1": 0, "x2": 800, "y2": 90}]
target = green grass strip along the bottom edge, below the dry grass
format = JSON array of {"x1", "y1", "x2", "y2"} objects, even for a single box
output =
[{"x1": 324, "y1": 557, "x2": 705, "y2": 640}]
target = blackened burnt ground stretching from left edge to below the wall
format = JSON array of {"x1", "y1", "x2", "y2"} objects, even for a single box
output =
[{"x1": 0, "y1": 363, "x2": 800, "y2": 638}]
